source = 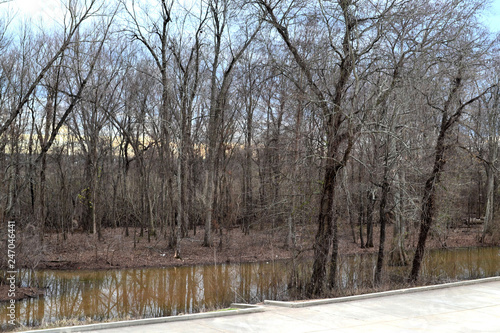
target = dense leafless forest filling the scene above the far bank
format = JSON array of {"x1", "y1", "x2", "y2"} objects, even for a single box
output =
[{"x1": 0, "y1": 0, "x2": 500, "y2": 296}]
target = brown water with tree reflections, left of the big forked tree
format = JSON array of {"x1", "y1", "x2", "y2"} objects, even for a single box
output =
[{"x1": 2, "y1": 262, "x2": 288, "y2": 328}]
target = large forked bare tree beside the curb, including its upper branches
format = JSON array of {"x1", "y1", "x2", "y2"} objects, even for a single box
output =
[{"x1": 258, "y1": 0, "x2": 394, "y2": 295}]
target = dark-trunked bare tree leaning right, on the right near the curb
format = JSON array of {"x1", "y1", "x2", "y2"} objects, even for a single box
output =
[{"x1": 409, "y1": 0, "x2": 490, "y2": 282}]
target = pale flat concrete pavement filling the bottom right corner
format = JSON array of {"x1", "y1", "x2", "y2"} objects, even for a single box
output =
[{"x1": 26, "y1": 278, "x2": 500, "y2": 333}]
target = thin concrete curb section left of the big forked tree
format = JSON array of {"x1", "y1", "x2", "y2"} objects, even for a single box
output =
[{"x1": 25, "y1": 303, "x2": 265, "y2": 333}]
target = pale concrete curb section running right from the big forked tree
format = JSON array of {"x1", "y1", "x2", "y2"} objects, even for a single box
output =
[{"x1": 264, "y1": 276, "x2": 500, "y2": 308}]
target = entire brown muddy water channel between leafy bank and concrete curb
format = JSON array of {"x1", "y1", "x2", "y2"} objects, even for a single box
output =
[{"x1": 0, "y1": 247, "x2": 500, "y2": 331}]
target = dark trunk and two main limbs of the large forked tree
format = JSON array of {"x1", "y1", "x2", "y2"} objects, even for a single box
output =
[{"x1": 259, "y1": 0, "x2": 357, "y2": 296}]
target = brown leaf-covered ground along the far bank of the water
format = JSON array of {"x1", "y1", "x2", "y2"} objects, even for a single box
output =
[{"x1": 0, "y1": 220, "x2": 498, "y2": 301}]
